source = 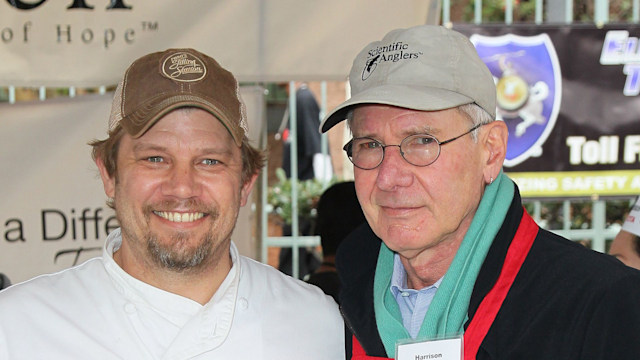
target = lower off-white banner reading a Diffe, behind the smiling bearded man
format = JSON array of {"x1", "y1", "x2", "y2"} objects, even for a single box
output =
[{"x1": 0, "y1": 87, "x2": 263, "y2": 283}]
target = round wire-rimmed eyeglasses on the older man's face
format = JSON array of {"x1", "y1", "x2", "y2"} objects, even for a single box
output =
[{"x1": 342, "y1": 124, "x2": 484, "y2": 170}]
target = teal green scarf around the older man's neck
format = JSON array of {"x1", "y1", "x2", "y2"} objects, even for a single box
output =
[{"x1": 373, "y1": 171, "x2": 514, "y2": 356}]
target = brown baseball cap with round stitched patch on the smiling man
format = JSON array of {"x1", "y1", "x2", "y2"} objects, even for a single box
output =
[{"x1": 109, "y1": 49, "x2": 248, "y2": 146}]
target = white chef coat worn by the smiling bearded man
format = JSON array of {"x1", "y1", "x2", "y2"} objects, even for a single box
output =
[{"x1": 0, "y1": 229, "x2": 344, "y2": 360}]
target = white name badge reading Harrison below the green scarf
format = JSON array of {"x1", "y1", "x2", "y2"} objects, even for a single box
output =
[{"x1": 396, "y1": 336, "x2": 463, "y2": 360}]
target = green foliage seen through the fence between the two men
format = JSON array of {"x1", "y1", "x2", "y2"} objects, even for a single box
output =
[{"x1": 267, "y1": 168, "x2": 335, "y2": 225}]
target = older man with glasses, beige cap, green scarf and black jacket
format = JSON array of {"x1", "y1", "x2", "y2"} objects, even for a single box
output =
[{"x1": 321, "y1": 26, "x2": 640, "y2": 360}]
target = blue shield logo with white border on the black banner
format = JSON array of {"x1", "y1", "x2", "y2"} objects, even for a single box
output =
[{"x1": 470, "y1": 34, "x2": 562, "y2": 167}]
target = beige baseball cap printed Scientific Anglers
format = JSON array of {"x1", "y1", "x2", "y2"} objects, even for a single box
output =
[{"x1": 320, "y1": 25, "x2": 496, "y2": 132}]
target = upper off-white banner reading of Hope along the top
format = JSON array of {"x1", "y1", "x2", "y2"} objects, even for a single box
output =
[{"x1": 0, "y1": 0, "x2": 438, "y2": 87}]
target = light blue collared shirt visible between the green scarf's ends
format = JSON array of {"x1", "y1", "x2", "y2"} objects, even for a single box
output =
[{"x1": 391, "y1": 254, "x2": 442, "y2": 339}]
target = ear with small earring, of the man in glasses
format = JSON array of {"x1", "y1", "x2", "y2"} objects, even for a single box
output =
[{"x1": 482, "y1": 120, "x2": 509, "y2": 184}]
